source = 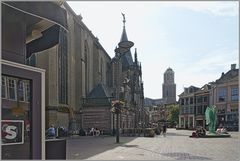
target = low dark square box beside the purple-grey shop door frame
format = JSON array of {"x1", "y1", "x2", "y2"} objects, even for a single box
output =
[{"x1": 46, "y1": 139, "x2": 66, "y2": 160}]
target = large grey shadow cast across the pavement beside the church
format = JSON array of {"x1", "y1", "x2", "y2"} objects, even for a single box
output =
[{"x1": 67, "y1": 136, "x2": 137, "y2": 160}]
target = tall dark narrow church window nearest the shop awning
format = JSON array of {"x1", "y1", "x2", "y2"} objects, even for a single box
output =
[{"x1": 58, "y1": 28, "x2": 68, "y2": 104}]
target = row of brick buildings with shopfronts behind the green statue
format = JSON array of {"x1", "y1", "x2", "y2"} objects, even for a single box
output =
[{"x1": 178, "y1": 64, "x2": 239, "y2": 130}]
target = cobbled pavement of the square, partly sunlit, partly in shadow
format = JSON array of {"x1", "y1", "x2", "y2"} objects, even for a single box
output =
[{"x1": 67, "y1": 129, "x2": 240, "y2": 160}]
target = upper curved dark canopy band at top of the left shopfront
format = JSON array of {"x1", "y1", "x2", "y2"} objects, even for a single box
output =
[{"x1": 1, "y1": 1, "x2": 68, "y2": 30}]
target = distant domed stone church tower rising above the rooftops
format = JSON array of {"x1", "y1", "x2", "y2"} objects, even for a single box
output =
[{"x1": 162, "y1": 68, "x2": 176, "y2": 104}]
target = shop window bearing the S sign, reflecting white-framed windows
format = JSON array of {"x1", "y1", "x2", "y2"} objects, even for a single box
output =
[{"x1": 1, "y1": 76, "x2": 32, "y2": 160}]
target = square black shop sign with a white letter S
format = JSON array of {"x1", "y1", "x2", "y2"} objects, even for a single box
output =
[{"x1": 1, "y1": 120, "x2": 24, "y2": 145}]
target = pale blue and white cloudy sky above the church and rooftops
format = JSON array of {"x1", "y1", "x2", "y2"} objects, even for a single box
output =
[{"x1": 68, "y1": 1, "x2": 239, "y2": 98}]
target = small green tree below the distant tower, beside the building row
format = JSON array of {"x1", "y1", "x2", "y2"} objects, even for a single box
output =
[{"x1": 167, "y1": 104, "x2": 179, "y2": 127}]
